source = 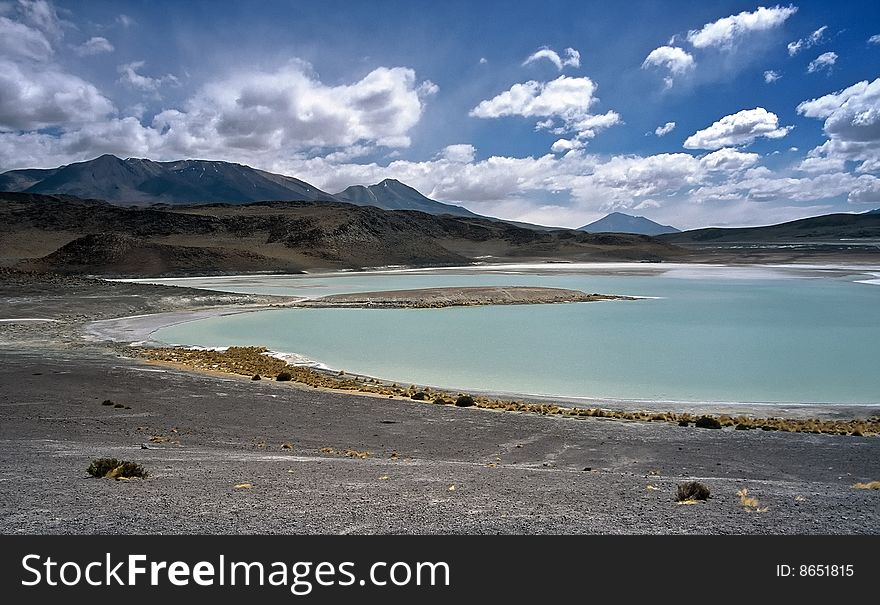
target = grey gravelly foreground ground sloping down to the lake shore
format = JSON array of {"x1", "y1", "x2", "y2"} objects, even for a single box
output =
[{"x1": 0, "y1": 272, "x2": 880, "y2": 534}]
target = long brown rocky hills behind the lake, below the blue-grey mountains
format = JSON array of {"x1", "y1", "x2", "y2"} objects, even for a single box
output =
[{"x1": 0, "y1": 193, "x2": 685, "y2": 275}]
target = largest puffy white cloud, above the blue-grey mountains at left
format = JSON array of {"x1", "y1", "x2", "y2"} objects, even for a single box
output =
[{"x1": 153, "y1": 63, "x2": 437, "y2": 154}]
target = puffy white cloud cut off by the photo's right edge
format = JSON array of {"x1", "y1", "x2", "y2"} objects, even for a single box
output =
[{"x1": 797, "y1": 78, "x2": 880, "y2": 172}]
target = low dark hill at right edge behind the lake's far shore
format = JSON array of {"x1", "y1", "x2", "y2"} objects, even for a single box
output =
[{"x1": 660, "y1": 213, "x2": 880, "y2": 245}]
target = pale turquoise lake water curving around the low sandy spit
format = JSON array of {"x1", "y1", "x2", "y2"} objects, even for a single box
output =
[{"x1": 144, "y1": 264, "x2": 880, "y2": 405}]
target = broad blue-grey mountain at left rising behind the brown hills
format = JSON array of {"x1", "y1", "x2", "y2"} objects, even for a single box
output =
[{"x1": 0, "y1": 155, "x2": 335, "y2": 204}]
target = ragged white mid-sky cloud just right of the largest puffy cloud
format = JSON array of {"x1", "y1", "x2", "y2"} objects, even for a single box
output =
[{"x1": 469, "y1": 76, "x2": 621, "y2": 147}]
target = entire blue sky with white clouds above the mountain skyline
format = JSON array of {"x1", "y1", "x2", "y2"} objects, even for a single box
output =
[{"x1": 0, "y1": 0, "x2": 880, "y2": 228}]
